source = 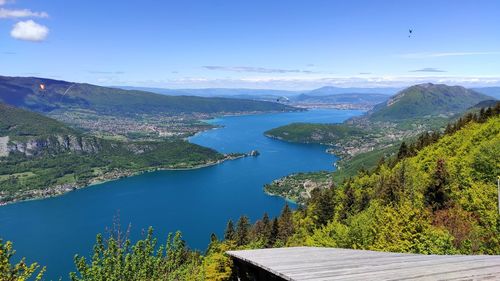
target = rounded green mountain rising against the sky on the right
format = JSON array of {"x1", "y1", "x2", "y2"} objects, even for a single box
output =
[{"x1": 369, "y1": 83, "x2": 491, "y2": 121}]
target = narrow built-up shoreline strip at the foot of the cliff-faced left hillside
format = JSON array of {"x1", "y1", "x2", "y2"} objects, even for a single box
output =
[{"x1": 0, "y1": 153, "x2": 250, "y2": 208}]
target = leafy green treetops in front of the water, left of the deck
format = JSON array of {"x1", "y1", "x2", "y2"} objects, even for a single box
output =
[{"x1": 70, "y1": 228, "x2": 202, "y2": 281}]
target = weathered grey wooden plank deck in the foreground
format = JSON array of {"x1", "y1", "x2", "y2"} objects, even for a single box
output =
[{"x1": 227, "y1": 247, "x2": 500, "y2": 280}]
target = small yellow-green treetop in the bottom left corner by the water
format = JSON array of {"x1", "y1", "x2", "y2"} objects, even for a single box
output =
[{"x1": 0, "y1": 239, "x2": 45, "y2": 281}]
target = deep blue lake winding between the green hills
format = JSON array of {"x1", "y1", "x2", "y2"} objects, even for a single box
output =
[{"x1": 0, "y1": 107, "x2": 361, "y2": 278}]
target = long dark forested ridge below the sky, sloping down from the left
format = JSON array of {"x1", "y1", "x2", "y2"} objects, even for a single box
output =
[{"x1": 0, "y1": 76, "x2": 295, "y2": 115}]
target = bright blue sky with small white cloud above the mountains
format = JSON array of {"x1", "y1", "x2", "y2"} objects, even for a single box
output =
[{"x1": 0, "y1": 0, "x2": 500, "y2": 90}]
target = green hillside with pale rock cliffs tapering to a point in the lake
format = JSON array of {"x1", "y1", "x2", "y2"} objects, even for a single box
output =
[{"x1": 0, "y1": 103, "x2": 224, "y2": 205}]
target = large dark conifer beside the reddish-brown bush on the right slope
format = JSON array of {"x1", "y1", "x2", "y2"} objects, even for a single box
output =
[{"x1": 425, "y1": 159, "x2": 449, "y2": 211}]
